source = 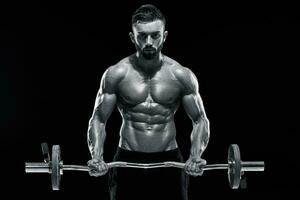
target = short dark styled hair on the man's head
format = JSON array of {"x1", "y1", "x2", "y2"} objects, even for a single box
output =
[{"x1": 131, "y1": 4, "x2": 166, "y2": 27}]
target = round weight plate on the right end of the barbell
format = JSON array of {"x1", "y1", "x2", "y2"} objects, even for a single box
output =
[{"x1": 227, "y1": 144, "x2": 242, "y2": 189}]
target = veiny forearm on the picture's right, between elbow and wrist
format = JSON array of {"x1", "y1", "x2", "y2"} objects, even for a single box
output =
[{"x1": 190, "y1": 116, "x2": 210, "y2": 161}]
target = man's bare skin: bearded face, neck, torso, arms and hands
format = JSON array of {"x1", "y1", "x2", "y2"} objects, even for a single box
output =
[{"x1": 88, "y1": 20, "x2": 209, "y2": 176}]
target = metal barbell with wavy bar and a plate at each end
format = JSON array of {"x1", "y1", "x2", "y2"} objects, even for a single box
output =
[{"x1": 25, "y1": 143, "x2": 265, "y2": 190}]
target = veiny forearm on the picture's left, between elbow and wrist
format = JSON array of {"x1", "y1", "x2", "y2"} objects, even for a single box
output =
[{"x1": 87, "y1": 117, "x2": 106, "y2": 160}]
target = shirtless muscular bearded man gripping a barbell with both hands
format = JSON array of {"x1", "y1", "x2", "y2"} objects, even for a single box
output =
[{"x1": 88, "y1": 5, "x2": 209, "y2": 200}]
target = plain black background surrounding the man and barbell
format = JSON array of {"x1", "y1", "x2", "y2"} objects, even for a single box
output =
[{"x1": 0, "y1": 1, "x2": 300, "y2": 199}]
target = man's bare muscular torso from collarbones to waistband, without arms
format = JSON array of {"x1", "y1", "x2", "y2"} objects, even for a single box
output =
[{"x1": 117, "y1": 54, "x2": 182, "y2": 152}]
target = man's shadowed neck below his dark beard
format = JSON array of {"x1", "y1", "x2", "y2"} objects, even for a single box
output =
[{"x1": 136, "y1": 52, "x2": 163, "y2": 73}]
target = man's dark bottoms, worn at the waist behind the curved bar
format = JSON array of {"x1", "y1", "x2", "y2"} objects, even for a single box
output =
[{"x1": 109, "y1": 148, "x2": 188, "y2": 200}]
